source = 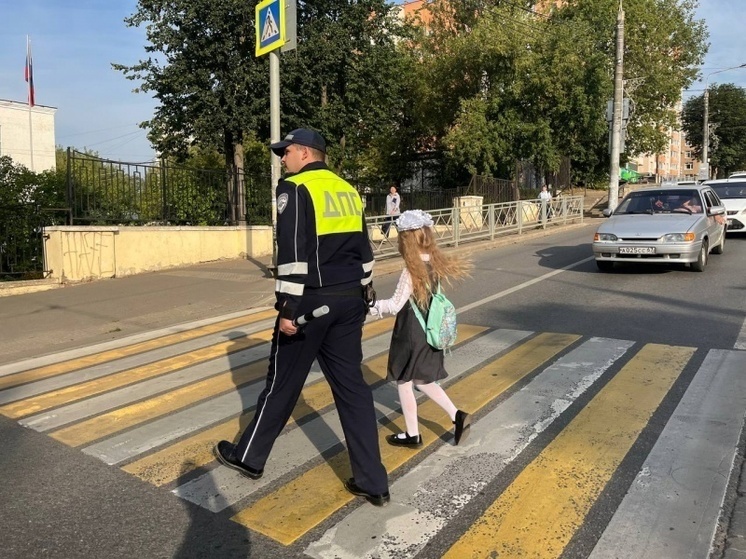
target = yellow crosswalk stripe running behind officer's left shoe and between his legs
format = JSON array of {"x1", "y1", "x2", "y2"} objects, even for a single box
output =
[{"x1": 122, "y1": 318, "x2": 398, "y2": 487}]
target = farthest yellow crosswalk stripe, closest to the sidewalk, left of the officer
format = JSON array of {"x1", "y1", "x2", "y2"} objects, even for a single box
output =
[{"x1": 0, "y1": 309, "x2": 277, "y2": 390}]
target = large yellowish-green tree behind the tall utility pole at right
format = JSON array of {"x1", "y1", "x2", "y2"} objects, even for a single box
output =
[{"x1": 404, "y1": 0, "x2": 705, "y2": 186}]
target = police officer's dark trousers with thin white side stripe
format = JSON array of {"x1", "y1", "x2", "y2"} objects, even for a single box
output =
[{"x1": 236, "y1": 288, "x2": 388, "y2": 494}]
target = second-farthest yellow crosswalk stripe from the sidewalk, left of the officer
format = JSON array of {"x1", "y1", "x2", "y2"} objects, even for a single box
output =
[{"x1": 0, "y1": 330, "x2": 272, "y2": 418}]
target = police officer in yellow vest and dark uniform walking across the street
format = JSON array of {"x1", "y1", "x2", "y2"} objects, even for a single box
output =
[{"x1": 214, "y1": 128, "x2": 389, "y2": 506}]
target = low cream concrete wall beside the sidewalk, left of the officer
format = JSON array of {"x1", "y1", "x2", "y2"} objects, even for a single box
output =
[{"x1": 44, "y1": 226, "x2": 272, "y2": 282}]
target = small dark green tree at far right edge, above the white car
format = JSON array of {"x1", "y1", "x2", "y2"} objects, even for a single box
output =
[{"x1": 681, "y1": 84, "x2": 746, "y2": 176}]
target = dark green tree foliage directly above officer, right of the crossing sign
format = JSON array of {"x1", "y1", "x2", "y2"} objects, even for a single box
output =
[{"x1": 281, "y1": 0, "x2": 407, "y2": 186}]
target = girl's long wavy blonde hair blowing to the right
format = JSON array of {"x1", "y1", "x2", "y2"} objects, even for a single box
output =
[{"x1": 399, "y1": 227, "x2": 471, "y2": 310}]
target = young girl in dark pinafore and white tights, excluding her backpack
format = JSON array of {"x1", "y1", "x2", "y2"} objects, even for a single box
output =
[{"x1": 371, "y1": 210, "x2": 470, "y2": 447}]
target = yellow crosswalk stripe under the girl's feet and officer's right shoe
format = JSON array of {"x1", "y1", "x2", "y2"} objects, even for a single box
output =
[{"x1": 232, "y1": 327, "x2": 579, "y2": 545}]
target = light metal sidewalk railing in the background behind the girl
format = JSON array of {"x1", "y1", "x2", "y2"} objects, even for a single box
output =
[{"x1": 366, "y1": 196, "x2": 585, "y2": 257}]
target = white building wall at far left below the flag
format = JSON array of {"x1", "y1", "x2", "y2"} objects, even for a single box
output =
[{"x1": 0, "y1": 99, "x2": 57, "y2": 173}]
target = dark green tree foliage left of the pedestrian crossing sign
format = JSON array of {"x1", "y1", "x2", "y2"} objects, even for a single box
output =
[{"x1": 113, "y1": 0, "x2": 269, "y2": 169}]
